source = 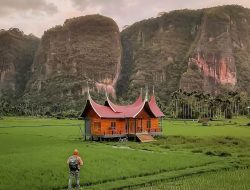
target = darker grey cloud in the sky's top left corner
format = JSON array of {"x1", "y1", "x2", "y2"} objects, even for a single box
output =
[{"x1": 0, "y1": 0, "x2": 58, "y2": 16}]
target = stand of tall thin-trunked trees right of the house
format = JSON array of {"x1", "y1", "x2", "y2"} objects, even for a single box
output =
[{"x1": 169, "y1": 89, "x2": 250, "y2": 119}]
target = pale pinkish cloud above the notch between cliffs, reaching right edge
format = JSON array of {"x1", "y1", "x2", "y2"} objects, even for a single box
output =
[{"x1": 71, "y1": 0, "x2": 250, "y2": 28}]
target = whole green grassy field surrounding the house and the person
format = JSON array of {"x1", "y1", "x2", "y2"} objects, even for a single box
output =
[{"x1": 0, "y1": 117, "x2": 250, "y2": 190}]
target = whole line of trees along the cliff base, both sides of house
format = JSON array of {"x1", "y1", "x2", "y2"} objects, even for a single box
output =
[{"x1": 0, "y1": 89, "x2": 250, "y2": 119}]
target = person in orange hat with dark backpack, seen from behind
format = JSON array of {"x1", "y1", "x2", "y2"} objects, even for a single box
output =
[{"x1": 67, "y1": 149, "x2": 83, "y2": 190}]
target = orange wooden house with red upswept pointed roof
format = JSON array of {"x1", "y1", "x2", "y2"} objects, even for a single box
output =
[{"x1": 81, "y1": 89, "x2": 164, "y2": 140}]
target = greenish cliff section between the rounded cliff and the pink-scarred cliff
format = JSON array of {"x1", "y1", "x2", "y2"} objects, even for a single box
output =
[{"x1": 118, "y1": 10, "x2": 202, "y2": 100}]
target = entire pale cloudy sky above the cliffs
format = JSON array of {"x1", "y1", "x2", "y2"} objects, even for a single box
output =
[{"x1": 0, "y1": 0, "x2": 250, "y2": 37}]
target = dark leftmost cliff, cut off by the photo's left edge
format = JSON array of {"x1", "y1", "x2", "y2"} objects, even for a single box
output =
[{"x1": 0, "y1": 28, "x2": 39, "y2": 98}]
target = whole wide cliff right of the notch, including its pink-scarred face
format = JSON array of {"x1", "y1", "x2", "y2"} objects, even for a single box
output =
[{"x1": 118, "y1": 6, "x2": 250, "y2": 101}]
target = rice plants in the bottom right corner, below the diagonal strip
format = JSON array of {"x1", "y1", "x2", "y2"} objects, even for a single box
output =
[{"x1": 140, "y1": 168, "x2": 250, "y2": 190}]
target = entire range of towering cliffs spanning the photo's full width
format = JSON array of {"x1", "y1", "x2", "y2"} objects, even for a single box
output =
[{"x1": 0, "y1": 6, "x2": 250, "y2": 112}]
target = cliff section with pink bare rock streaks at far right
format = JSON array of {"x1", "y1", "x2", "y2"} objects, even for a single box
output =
[{"x1": 180, "y1": 7, "x2": 250, "y2": 94}]
